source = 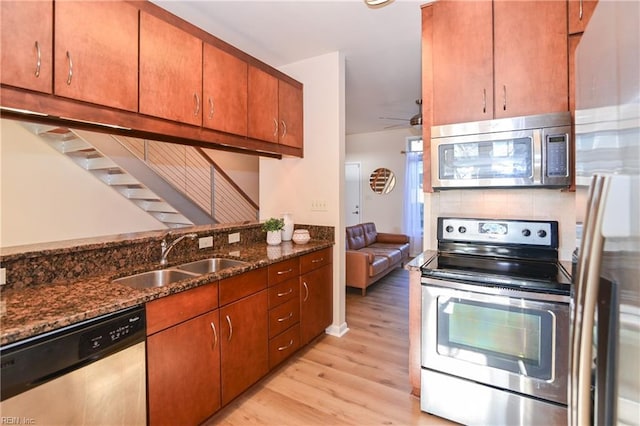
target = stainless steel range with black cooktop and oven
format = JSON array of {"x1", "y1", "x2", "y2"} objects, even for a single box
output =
[{"x1": 420, "y1": 218, "x2": 571, "y2": 426}]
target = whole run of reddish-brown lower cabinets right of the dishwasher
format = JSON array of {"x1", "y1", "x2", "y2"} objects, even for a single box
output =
[{"x1": 146, "y1": 248, "x2": 333, "y2": 425}]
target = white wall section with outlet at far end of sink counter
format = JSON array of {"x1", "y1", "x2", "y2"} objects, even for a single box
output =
[{"x1": 260, "y1": 52, "x2": 347, "y2": 335}]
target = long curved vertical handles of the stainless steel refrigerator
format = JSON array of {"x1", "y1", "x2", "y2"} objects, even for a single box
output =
[{"x1": 569, "y1": 175, "x2": 610, "y2": 426}]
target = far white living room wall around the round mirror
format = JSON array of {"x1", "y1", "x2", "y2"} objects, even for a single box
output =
[{"x1": 345, "y1": 128, "x2": 422, "y2": 233}]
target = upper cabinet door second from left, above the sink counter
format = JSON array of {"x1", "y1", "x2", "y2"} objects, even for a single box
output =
[{"x1": 54, "y1": 1, "x2": 138, "y2": 111}]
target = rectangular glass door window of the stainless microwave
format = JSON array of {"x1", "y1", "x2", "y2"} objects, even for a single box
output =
[{"x1": 438, "y1": 137, "x2": 533, "y2": 180}]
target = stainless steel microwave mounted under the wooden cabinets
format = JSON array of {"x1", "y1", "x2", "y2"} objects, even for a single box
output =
[{"x1": 431, "y1": 112, "x2": 573, "y2": 190}]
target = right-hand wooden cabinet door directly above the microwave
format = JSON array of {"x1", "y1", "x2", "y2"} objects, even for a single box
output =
[{"x1": 494, "y1": 0, "x2": 569, "y2": 118}]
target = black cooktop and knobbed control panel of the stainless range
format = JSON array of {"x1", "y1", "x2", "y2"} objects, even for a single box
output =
[{"x1": 422, "y1": 218, "x2": 571, "y2": 295}]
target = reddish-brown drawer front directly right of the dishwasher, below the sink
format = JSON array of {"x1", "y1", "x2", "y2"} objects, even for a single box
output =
[{"x1": 146, "y1": 281, "x2": 218, "y2": 336}]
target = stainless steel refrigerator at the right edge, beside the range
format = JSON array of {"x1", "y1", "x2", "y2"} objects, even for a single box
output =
[{"x1": 569, "y1": 0, "x2": 640, "y2": 426}]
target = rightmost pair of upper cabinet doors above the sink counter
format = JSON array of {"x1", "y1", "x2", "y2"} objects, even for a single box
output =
[{"x1": 248, "y1": 66, "x2": 303, "y2": 148}]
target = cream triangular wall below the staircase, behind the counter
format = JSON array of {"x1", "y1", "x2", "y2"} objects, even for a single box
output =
[{"x1": 0, "y1": 119, "x2": 166, "y2": 247}]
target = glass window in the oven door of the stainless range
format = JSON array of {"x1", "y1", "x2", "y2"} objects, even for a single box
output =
[{"x1": 437, "y1": 297, "x2": 554, "y2": 380}]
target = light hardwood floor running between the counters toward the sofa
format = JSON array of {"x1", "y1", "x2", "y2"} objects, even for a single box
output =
[{"x1": 206, "y1": 269, "x2": 453, "y2": 426}]
